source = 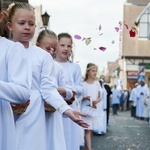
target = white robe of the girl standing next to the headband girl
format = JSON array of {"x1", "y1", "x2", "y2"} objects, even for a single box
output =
[{"x1": 55, "y1": 62, "x2": 84, "y2": 150}]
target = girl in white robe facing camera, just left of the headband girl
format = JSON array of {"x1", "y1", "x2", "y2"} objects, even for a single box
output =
[{"x1": 55, "y1": 33, "x2": 84, "y2": 150}]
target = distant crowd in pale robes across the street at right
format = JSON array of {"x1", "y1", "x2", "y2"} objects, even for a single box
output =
[{"x1": 111, "y1": 79, "x2": 150, "y2": 124}]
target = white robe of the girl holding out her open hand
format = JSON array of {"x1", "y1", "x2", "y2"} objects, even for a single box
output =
[{"x1": 16, "y1": 44, "x2": 70, "y2": 150}]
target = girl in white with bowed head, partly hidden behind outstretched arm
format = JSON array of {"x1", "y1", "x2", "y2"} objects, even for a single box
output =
[{"x1": 36, "y1": 30, "x2": 73, "y2": 150}]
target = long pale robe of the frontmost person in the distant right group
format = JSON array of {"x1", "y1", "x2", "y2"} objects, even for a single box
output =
[{"x1": 136, "y1": 85, "x2": 148, "y2": 117}]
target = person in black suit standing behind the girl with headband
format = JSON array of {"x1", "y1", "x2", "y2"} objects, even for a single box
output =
[{"x1": 100, "y1": 75, "x2": 112, "y2": 125}]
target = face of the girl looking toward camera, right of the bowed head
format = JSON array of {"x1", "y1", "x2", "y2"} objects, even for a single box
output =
[{"x1": 56, "y1": 37, "x2": 72, "y2": 61}]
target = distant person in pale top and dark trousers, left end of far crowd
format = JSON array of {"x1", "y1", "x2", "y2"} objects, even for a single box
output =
[{"x1": 111, "y1": 85, "x2": 121, "y2": 115}]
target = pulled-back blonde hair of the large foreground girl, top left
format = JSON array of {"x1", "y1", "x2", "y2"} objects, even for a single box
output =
[{"x1": 8, "y1": 3, "x2": 34, "y2": 22}]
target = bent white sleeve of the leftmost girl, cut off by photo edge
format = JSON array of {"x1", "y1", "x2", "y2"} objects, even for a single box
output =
[{"x1": 0, "y1": 43, "x2": 31, "y2": 103}]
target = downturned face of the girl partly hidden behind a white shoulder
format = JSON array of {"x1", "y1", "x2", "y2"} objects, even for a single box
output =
[{"x1": 37, "y1": 37, "x2": 57, "y2": 56}]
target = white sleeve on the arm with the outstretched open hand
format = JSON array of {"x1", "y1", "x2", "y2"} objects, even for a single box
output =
[{"x1": 40, "y1": 53, "x2": 71, "y2": 113}]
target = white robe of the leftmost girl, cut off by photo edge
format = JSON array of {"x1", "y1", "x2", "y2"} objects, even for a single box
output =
[{"x1": 0, "y1": 37, "x2": 29, "y2": 150}]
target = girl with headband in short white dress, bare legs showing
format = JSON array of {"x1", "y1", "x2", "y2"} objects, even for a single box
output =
[{"x1": 82, "y1": 63, "x2": 100, "y2": 150}]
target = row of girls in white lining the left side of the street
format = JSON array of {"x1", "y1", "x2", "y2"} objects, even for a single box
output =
[{"x1": 0, "y1": 3, "x2": 111, "y2": 150}]
